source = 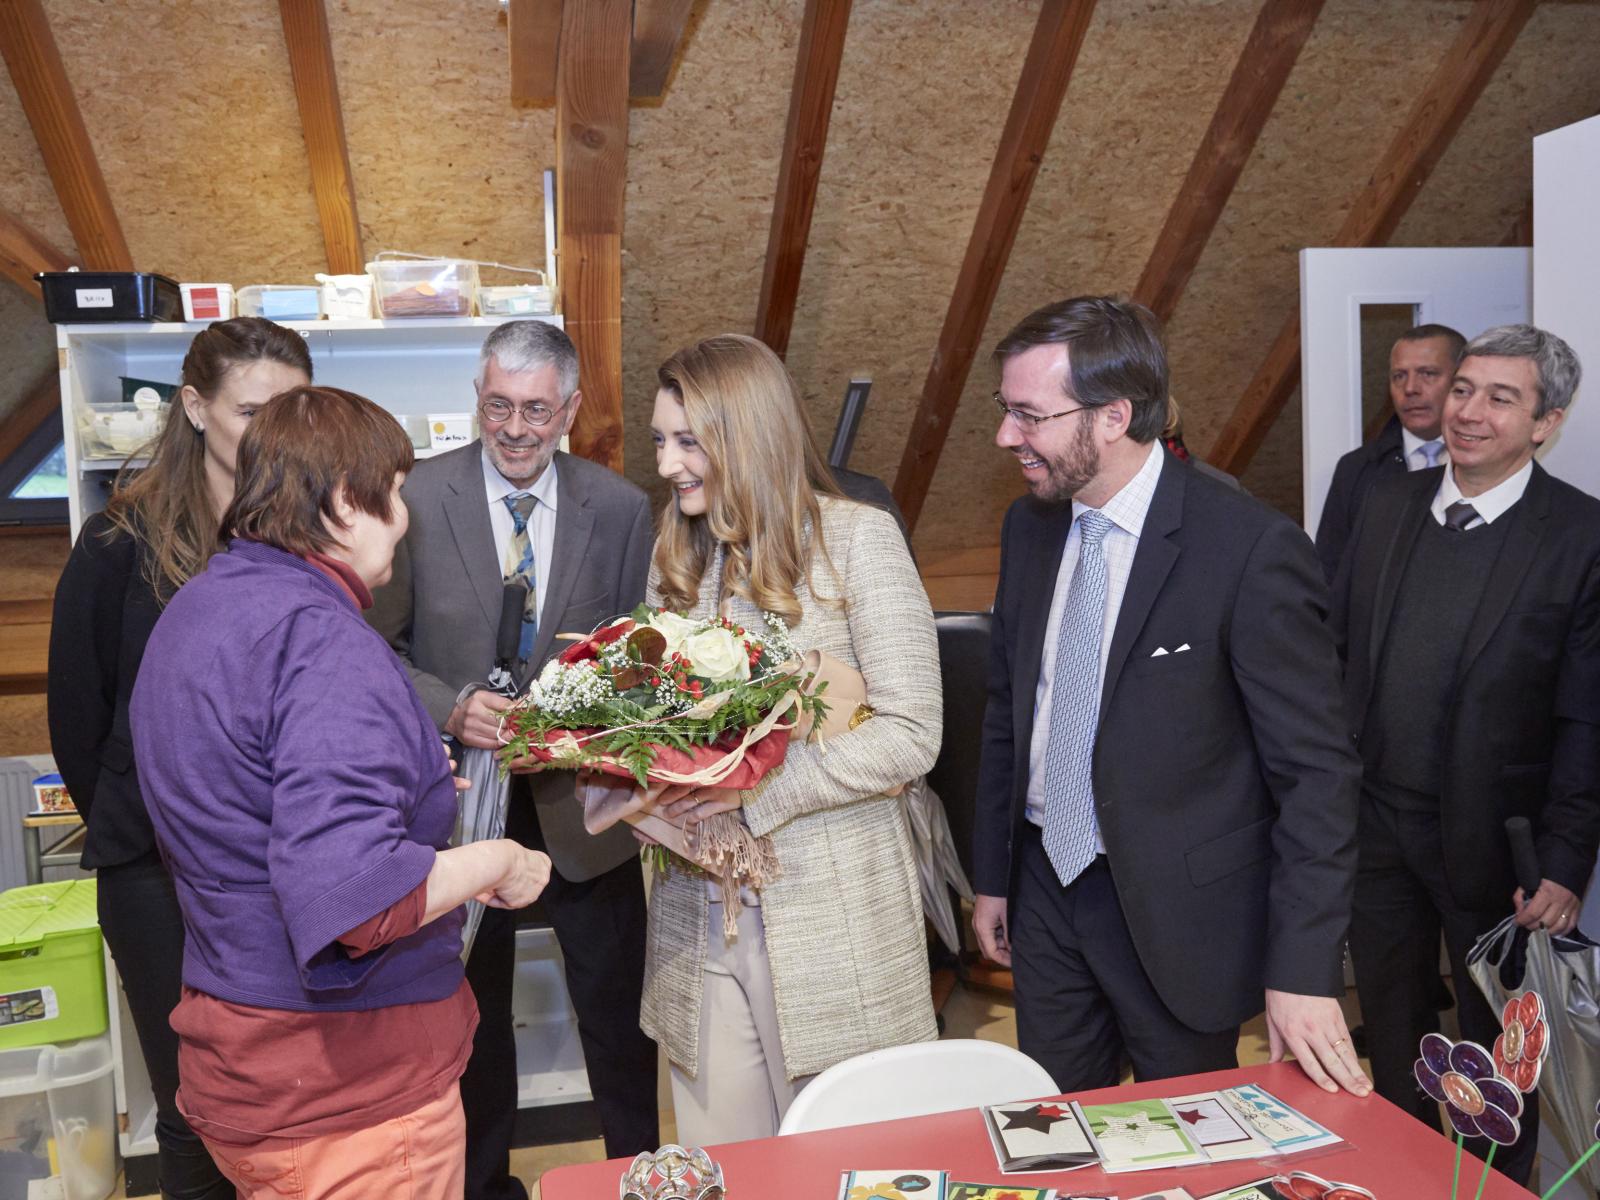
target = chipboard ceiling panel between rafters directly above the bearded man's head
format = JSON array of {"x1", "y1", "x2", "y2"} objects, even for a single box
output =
[{"x1": 917, "y1": 0, "x2": 1258, "y2": 546}]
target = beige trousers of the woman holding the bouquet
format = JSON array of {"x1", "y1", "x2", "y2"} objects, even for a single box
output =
[{"x1": 672, "y1": 901, "x2": 814, "y2": 1146}]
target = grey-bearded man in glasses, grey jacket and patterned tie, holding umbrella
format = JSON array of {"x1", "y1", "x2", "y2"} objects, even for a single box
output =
[{"x1": 371, "y1": 322, "x2": 659, "y2": 1200}]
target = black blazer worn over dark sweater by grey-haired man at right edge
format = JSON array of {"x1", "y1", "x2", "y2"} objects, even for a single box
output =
[{"x1": 1331, "y1": 462, "x2": 1600, "y2": 910}]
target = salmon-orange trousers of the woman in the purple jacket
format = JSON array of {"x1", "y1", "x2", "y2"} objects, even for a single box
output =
[{"x1": 196, "y1": 1083, "x2": 467, "y2": 1200}]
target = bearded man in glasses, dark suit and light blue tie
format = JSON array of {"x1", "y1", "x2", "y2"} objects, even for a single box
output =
[{"x1": 973, "y1": 296, "x2": 1370, "y2": 1094}]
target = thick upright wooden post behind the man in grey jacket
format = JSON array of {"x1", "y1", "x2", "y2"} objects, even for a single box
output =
[{"x1": 555, "y1": 0, "x2": 634, "y2": 470}]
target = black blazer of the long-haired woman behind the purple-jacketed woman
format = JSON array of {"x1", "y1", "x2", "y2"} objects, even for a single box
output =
[{"x1": 46, "y1": 514, "x2": 162, "y2": 869}]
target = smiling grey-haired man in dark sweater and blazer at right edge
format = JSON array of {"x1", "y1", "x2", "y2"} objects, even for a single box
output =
[{"x1": 1333, "y1": 325, "x2": 1600, "y2": 1181}]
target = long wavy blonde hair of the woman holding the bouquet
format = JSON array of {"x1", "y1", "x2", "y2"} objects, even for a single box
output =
[{"x1": 656, "y1": 333, "x2": 842, "y2": 624}]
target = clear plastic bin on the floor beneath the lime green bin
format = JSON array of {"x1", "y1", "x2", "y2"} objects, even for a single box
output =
[{"x1": 0, "y1": 1037, "x2": 117, "y2": 1200}]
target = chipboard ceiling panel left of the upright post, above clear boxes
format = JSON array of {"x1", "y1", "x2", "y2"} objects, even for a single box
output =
[{"x1": 321, "y1": 0, "x2": 560, "y2": 273}]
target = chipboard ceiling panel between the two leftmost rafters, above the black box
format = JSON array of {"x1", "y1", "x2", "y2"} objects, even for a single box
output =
[{"x1": 46, "y1": 0, "x2": 325, "y2": 285}]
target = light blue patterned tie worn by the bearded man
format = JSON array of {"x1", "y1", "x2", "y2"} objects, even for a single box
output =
[{"x1": 1045, "y1": 509, "x2": 1110, "y2": 885}]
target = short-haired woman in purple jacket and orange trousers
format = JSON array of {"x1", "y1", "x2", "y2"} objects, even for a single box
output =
[{"x1": 131, "y1": 387, "x2": 550, "y2": 1200}]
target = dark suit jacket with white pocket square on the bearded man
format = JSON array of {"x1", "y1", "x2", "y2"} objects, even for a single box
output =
[{"x1": 973, "y1": 454, "x2": 1360, "y2": 1030}]
